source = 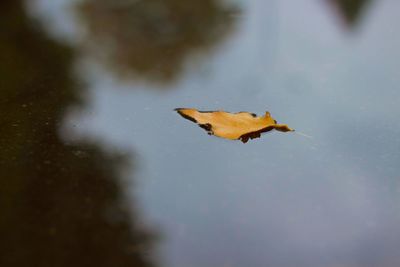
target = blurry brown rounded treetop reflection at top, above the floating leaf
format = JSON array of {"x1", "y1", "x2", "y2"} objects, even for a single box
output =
[{"x1": 79, "y1": 0, "x2": 236, "y2": 82}]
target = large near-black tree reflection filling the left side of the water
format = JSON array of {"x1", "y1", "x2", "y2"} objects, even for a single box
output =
[{"x1": 0, "y1": 0, "x2": 154, "y2": 267}]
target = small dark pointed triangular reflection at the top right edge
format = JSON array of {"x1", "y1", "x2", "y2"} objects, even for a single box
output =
[{"x1": 329, "y1": 0, "x2": 371, "y2": 28}]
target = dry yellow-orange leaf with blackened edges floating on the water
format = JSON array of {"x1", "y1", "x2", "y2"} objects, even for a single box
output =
[{"x1": 175, "y1": 108, "x2": 294, "y2": 143}]
